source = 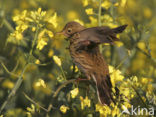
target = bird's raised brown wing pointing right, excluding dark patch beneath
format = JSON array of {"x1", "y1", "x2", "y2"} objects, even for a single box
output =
[{"x1": 80, "y1": 25, "x2": 127, "y2": 44}]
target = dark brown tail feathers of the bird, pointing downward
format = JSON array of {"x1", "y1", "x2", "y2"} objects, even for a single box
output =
[{"x1": 96, "y1": 75, "x2": 119, "y2": 106}]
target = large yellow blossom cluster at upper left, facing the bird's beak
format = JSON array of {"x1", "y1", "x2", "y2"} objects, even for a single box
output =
[{"x1": 8, "y1": 8, "x2": 57, "y2": 50}]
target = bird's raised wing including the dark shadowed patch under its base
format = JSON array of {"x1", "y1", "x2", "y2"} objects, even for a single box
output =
[{"x1": 72, "y1": 25, "x2": 127, "y2": 49}]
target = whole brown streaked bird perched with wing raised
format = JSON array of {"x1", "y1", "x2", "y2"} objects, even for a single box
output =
[{"x1": 57, "y1": 22, "x2": 127, "y2": 105}]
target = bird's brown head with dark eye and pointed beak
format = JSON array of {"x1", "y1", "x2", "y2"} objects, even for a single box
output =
[{"x1": 57, "y1": 21, "x2": 85, "y2": 37}]
